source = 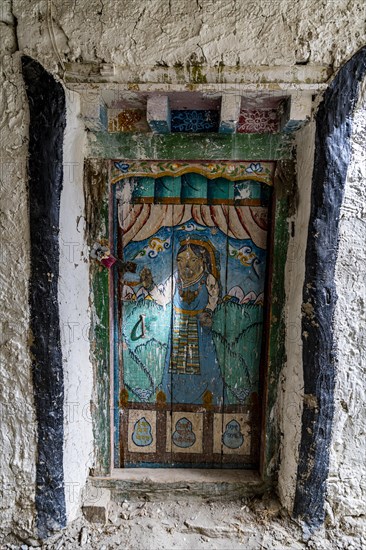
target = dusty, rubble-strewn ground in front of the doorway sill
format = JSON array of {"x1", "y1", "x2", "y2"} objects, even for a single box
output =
[{"x1": 2, "y1": 496, "x2": 366, "y2": 550}]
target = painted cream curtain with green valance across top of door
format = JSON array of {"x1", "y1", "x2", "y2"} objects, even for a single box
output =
[{"x1": 119, "y1": 174, "x2": 269, "y2": 248}]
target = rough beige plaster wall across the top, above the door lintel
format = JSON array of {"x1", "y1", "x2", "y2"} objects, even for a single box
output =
[{"x1": 14, "y1": 0, "x2": 365, "y2": 72}]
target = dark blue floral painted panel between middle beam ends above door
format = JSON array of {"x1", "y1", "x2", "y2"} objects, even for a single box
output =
[{"x1": 171, "y1": 110, "x2": 219, "y2": 133}]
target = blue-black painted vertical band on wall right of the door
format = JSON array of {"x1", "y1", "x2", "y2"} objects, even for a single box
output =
[{"x1": 293, "y1": 47, "x2": 366, "y2": 531}]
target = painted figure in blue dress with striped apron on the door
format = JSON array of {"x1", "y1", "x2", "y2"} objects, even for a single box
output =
[{"x1": 137, "y1": 239, "x2": 224, "y2": 404}]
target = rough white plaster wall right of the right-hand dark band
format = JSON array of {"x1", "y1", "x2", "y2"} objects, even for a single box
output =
[{"x1": 327, "y1": 79, "x2": 366, "y2": 543}]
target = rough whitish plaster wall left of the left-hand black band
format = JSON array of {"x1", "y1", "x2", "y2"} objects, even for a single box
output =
[{"x1": 0, "y1": 2, "x2": 37, "y2": 544}]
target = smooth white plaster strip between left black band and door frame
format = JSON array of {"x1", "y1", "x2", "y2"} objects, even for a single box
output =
[{"x1": 59, "y1": 89, "x2": 93, "y2": 520}]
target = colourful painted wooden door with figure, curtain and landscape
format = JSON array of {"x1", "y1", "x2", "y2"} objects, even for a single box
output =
[{"x1": 114, "y1": 163, "x2": 271, "y2": 468}]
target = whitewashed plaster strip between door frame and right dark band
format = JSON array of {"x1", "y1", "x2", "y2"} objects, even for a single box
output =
[{"x1": 277, "y1": 121, "x2": 315, "y2": 511}]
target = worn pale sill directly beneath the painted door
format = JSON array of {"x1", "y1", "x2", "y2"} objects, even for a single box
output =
[{"x1": 88, "y1": 468, "x2": 270, "y2": 502}]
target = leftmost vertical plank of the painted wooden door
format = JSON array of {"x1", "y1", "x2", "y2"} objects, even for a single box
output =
[{"x1": 120, "y1": 194, "x2": 173, "y2": 465}]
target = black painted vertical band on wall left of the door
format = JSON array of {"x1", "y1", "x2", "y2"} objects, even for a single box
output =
[{"x1": 22, "y1": 57, "x2": 66, "y2": 538}]
